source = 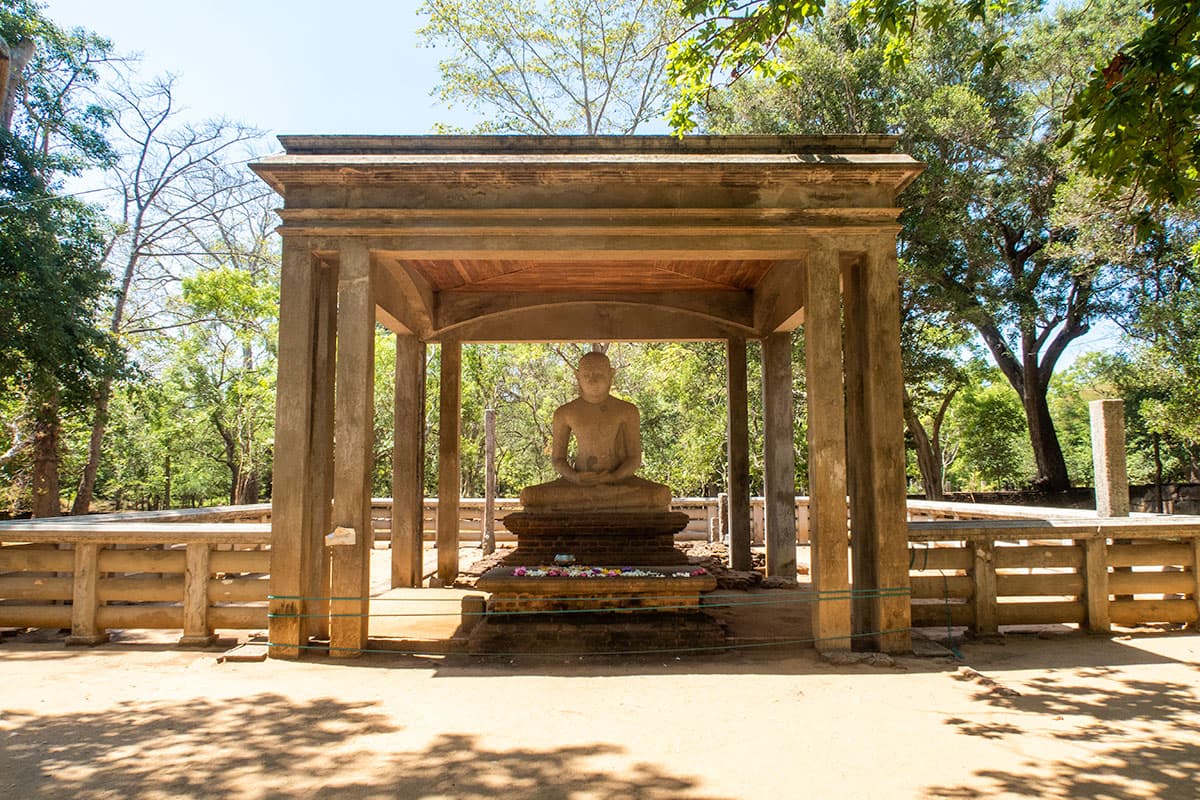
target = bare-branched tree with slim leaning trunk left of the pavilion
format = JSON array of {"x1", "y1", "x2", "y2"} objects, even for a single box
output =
[{"x1": 72, "y1": 76, "x2": 262, "y2": 515}]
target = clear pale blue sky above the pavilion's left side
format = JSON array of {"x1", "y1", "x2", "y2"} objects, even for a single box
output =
[{"x1": 46, "y1": 0, "x2": 475, "y2": 134}]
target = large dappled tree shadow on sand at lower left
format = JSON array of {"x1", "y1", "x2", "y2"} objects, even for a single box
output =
[{"x1": 0, "y1": 693, "x2": 724, "y2": 800}]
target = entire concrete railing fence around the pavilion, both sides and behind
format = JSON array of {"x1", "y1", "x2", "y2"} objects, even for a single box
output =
[{"x1": 0, "y1": 497, "x2": 1200, "y2": 645}]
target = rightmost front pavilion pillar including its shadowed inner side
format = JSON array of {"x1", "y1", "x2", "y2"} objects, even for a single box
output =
[{"x1": 844, "y1": 236, "x2": 912, "y2": 652}]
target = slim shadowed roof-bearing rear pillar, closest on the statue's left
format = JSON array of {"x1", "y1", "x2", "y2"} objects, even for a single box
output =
[{"x1": 438, "y1": 342, "x2": 462, "y2": 587}]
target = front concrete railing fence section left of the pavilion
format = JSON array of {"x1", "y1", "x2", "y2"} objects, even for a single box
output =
[{"x1": 0, "y1": 515, "x2": 271, "y2": 645}]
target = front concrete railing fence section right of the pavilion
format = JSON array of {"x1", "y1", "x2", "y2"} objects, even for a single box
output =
[{"x1": 908, "y1": 517, "x2": 1200, "y2": 633}]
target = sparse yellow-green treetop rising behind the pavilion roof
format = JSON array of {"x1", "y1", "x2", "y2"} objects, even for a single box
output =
[{"x1": 418, "y1": 0, "x2": 677, "y2": 134}]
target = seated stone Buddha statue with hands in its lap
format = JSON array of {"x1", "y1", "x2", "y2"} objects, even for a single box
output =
[{"x1": 521, "y1": 353, "x2": 671, "y2": 513}]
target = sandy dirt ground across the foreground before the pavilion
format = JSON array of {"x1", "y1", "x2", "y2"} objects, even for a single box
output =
[{"x1": 0, "y1": 633, "x2": 1200, "y2": 800}]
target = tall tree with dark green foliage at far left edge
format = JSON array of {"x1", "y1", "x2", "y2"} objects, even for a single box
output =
[{"x1": 0, "y1": 0, "x2": 116, "y2": 516}]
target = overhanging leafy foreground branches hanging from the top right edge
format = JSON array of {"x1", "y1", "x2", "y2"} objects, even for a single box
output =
[{"x1": 667, "y1": 0, "x2": 1200, "y2": 204}]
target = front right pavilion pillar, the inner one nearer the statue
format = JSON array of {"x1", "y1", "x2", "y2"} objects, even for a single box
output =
[{"x1": 804, "y1": 251, "x2": 851, "y2": 652}]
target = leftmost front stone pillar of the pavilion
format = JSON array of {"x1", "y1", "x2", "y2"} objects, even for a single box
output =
[{"x1": 269, "y1": 236, "x2": 317, "y2": 658}]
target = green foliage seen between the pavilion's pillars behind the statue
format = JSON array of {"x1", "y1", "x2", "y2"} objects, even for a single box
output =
[{"x1": 398, "y1": 343, "x2": 763, "y2": 497}]
